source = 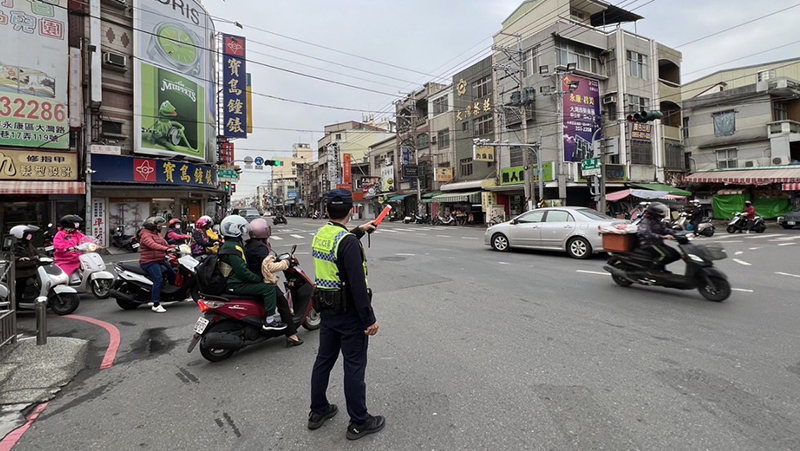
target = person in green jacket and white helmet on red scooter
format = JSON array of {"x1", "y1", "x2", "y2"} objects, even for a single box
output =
[{"x1": 219, "y1": 215, "x2": 286, "y2": 330}]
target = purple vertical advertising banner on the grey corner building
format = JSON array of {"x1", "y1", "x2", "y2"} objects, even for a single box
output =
[{"x1": 561, "y1": 74, "x2": 601, "y2": 161}]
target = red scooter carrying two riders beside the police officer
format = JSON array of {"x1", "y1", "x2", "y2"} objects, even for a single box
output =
[{"x1": 187, "y1": 245, "x2": 321, "y2": 362}]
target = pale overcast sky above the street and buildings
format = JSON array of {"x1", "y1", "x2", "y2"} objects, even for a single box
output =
[{"x1": 203, "y1": 0, "x2": 800, "y2": 197}]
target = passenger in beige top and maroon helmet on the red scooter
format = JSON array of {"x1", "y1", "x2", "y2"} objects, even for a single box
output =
[{"x1": 244, "y1": 218, "x2": 303, "y2": 347}]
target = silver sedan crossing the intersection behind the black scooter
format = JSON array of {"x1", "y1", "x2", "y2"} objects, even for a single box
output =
[{"x1": 484, "y1": 207, "x2": 627, "y2": 258}]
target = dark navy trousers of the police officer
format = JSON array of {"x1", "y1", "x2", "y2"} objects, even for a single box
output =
[{"x1": 311, "y1": 310, "x2": 369, "y2": 424}]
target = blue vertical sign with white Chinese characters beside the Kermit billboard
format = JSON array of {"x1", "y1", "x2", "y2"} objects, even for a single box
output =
[{"x1": 221, "y1": 34, "x2": 248, "y2": 138}]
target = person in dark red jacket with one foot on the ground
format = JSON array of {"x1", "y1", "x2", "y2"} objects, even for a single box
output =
[{"x1": 139, "y1": 216, "x2": 175, "y2": 313}]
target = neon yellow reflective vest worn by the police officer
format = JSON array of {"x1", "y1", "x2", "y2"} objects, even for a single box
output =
[{"x1": 311, "y1": 223, "x2": 367, "y2": 291}]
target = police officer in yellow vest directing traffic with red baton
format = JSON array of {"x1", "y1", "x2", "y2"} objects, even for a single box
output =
[{"x1": 308, "y1": 189, "x2": 385, "y2": 440}]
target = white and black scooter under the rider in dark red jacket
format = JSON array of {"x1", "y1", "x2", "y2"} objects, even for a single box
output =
[{"x1": 109, "y1": 244, "x2": 200, "y2": 310}]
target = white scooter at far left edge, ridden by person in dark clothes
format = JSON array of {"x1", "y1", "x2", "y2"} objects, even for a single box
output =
[{"x1": 0, "y1": 257, "x2": 81, "y2": 315}]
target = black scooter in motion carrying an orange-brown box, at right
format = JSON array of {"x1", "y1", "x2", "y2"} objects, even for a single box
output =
[{"x1": 603, "y1": 233, "x2": 731, "y2": 302}]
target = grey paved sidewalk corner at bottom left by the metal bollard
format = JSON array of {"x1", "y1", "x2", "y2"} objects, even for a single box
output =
[{"x1": 0, "y1": 337, "x2": 89, "y2": 439}]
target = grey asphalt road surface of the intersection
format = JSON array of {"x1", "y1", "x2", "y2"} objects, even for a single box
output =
[{"x1": 10, "y1": 218, "x2": 800, "y2": 451}]
